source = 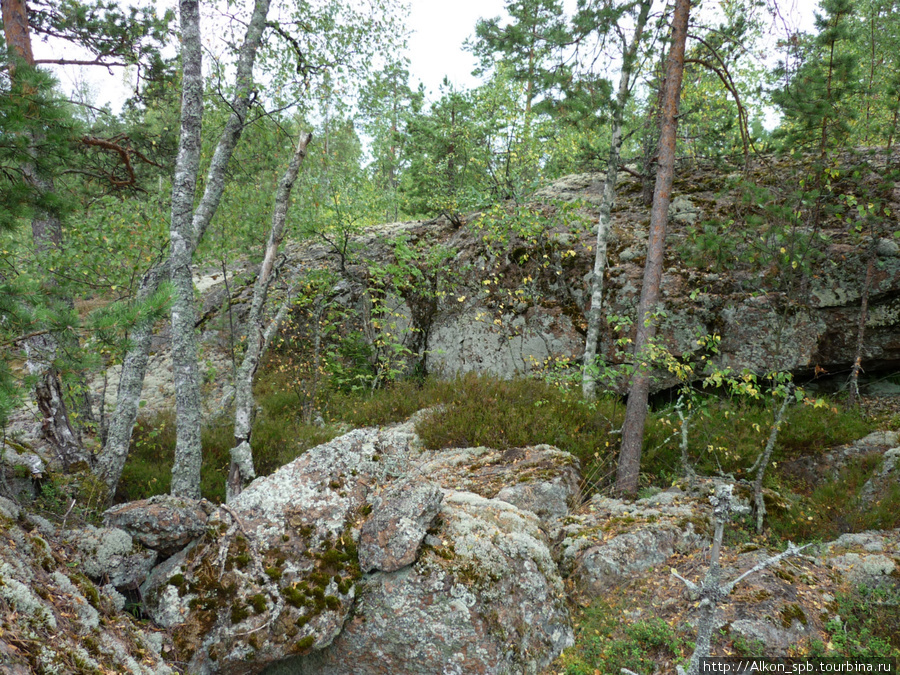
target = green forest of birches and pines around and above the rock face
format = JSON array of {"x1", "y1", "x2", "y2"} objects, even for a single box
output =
[{"x1": 0, "y1": 0, "x2": 900, "y2": 504}]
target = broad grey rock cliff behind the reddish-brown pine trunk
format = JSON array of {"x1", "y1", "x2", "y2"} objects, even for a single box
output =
[{"x1": 326, "y1": 155, "x2": 900, "y2": 388}]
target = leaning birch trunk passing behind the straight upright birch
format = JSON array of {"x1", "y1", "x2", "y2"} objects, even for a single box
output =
[{"x1": 99, "y1": 0, "x2": 270, "y2": 494}]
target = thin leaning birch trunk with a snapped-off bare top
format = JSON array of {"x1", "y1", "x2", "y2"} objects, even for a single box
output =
[{"x1": 226, "y1": 134, "x2": 312, "y2": 501}]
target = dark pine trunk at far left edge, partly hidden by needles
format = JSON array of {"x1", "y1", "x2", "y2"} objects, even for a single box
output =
[{"x1": 0, "y1": 0, "x2": 87, "y2": 471}]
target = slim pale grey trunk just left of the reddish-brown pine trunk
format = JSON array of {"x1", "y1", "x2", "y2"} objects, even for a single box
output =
[{"x1": 582, "y1": 0, "x2": 652, "y2": 400}]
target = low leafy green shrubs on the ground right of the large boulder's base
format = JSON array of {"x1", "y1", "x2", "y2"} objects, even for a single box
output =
[{"x1": 554, "y1": 598, "x2": 688, "y2": 675}]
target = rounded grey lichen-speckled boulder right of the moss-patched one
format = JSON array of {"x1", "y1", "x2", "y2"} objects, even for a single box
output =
[{"x1": 267, "y1": 492, "x2": 573, "y2": 675}]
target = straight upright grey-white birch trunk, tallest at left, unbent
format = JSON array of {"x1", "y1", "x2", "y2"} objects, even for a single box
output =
[{"x1": 169, "y1": 0, "x2": 203, "y2": 499}]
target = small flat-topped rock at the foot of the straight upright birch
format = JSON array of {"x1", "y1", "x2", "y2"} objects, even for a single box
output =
[{"x1": 103, "y1": 495, "x2": 215, "y2": 556}]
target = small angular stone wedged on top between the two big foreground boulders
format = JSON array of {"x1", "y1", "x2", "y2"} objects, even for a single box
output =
[{"x1": 359, "y1": 482, "x2": 444, "y2": 573}]
